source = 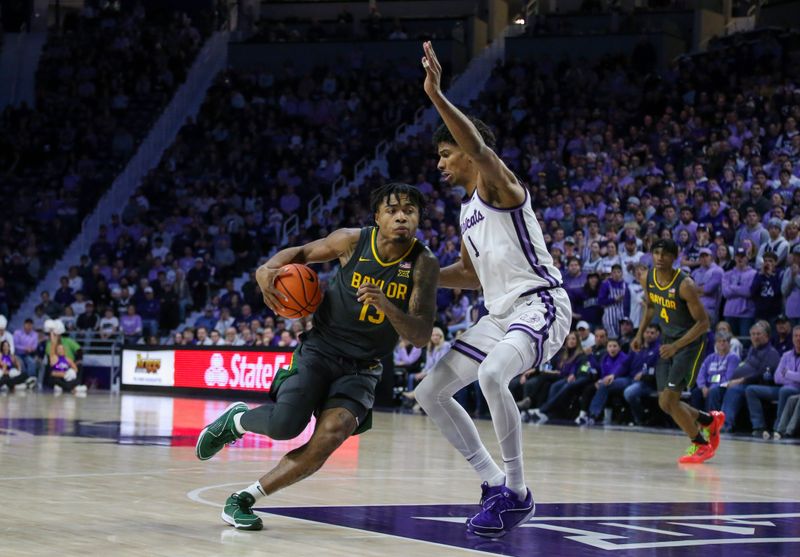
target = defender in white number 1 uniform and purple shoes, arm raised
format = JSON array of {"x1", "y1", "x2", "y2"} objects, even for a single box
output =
[{"x1": 416, "y1": 42, "x2": 572, "y2": 538}]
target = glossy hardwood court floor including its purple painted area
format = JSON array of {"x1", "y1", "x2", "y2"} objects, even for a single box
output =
[{"x1": 0, "y1": 393, "x2": 800, "y2": 557}]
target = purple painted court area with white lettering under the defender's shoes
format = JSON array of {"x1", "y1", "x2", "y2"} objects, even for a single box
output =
[{"x1": 266, "y1": 502, "x2": 800, "y2": 557}]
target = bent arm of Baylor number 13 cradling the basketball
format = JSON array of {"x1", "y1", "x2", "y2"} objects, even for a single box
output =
[{"x1": 256, "y1": 228, "x2": 361, "y2": 311}]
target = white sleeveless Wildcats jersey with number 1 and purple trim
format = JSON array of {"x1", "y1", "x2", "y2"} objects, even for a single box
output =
[{"x1": 461, "y1": 188, "x2": 561, "y2": 315}]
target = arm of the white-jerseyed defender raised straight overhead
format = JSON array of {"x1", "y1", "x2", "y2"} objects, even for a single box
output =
[{"x1": 422, "y1": 41, "x2": 525, "y2": 205}]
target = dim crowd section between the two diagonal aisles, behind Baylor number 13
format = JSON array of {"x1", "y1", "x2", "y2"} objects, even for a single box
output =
[{"x1": 0, "y1": 50, "x2": 432, "y2": 342}]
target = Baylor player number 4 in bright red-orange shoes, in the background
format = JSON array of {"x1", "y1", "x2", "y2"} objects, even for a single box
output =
[{"x1": 631, "y1": 239, "x2": 725, "y2": 464}]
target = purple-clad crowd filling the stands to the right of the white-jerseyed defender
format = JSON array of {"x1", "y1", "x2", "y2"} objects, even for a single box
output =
[{"x1": 388, "y1": 28, "x2": 800, "y2": 436}]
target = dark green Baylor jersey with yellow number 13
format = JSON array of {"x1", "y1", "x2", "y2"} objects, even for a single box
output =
[{"x1": 309, "y1": 227, "x2": 427, "y2": 360}]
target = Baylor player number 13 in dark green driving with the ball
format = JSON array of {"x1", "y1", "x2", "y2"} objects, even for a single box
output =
[{"x1": 195, "y1": 183, "x2": 439, "y2": 530}]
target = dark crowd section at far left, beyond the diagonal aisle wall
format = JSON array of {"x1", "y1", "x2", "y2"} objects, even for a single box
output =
[{"x1": 0, "y1": 2, "x2": 209, "y2": 314}]
